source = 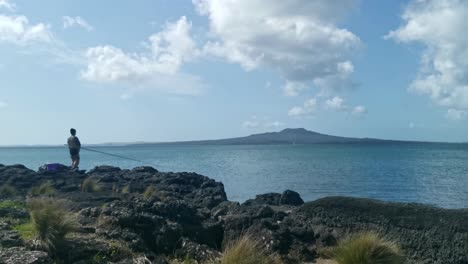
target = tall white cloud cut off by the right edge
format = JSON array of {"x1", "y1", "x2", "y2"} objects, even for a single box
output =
[{"x1": 386, "y1": 0, "x2": 468, "y2": 109}]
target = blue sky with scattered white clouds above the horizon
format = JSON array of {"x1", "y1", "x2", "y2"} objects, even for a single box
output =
[{"x1": 0, "y1": 0, "x2": 468, "y2": 145}]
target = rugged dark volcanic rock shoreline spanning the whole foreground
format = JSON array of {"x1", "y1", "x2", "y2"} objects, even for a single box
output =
[{"x1": 0, "y1": 165, "x2": 468, "y2": 264}]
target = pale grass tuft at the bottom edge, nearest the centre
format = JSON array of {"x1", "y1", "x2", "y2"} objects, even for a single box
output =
[{"x1": 218, "y1": 235, "x2": 281, "y2": 264}]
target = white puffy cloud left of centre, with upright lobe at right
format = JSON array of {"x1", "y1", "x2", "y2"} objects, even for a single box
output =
[{"x1": 81, "y1": 17, "x2": 203, "y2": 94}]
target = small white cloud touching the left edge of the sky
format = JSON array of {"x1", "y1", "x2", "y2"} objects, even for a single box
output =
[{"x1": 0, "y1": 15, "x2": 53, "y2": 45}]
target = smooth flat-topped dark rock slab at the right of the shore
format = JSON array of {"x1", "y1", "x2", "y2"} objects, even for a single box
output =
[{"x1": 291, "y1": 197, "x2": 468, "y2": 264}]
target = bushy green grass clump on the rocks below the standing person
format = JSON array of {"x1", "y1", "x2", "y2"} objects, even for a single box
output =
[{"x1": 28, "y1": 198, "x2": 77, "y2": 253}]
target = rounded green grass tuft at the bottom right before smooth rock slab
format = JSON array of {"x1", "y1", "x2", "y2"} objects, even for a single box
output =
[{"x1": 333, "y1": 232, "x2": 405, "y2": 264}]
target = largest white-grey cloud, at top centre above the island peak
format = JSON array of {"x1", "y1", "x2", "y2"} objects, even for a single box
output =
[{"x1": 193, "y1": 0, "x2": 361, "y2": 95}]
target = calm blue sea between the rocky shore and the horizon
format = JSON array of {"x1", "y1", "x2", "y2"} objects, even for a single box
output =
[{"x1": 0, "y1": 143, "x2": 468, "y2": 208}]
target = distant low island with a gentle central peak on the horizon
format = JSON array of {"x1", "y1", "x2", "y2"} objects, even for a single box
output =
[{"x1": 130, "y1": 128, "x2": 405, "y2": 145}]
